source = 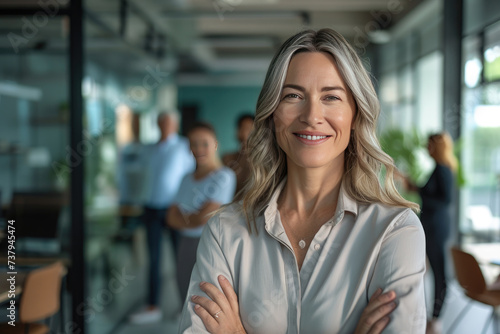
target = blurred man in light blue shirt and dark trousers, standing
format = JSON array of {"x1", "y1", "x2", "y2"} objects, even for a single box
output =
[{"x1": 130, "y1": 111, "x2": 195, "y2": 323}]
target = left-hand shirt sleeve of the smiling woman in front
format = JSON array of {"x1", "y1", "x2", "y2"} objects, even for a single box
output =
[{"x1": 178, "y1": 215, "x2": 234, "y2": 334}]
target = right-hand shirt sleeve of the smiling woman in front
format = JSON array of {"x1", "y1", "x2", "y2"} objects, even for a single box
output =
[{"x1": 367, "y1": 209, "x2": 427, "y2": 334}]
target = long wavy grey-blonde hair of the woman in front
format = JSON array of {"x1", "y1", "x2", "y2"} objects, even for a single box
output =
[{"x1": 236, "y1": 29, "x2": 419, "y2": 231}]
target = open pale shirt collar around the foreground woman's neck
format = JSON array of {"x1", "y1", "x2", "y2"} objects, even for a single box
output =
[{"x1": 264, "y1": 177, "x2": 358, "y2": 234}]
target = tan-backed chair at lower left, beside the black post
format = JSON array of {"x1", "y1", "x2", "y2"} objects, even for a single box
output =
[{"x1": 0, "y1": 262, "x2": 65, "y2": 334}]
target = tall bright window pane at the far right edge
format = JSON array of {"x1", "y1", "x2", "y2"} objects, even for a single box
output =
[{"x1": 459, "y1": 24, "x2": 500, "y2": 244}]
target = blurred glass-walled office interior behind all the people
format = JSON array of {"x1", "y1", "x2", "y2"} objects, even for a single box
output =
[{"x1": 0, "y1": 0, "x2": 500, "y2": 334}]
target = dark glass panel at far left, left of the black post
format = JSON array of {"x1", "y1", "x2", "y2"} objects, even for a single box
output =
[{"x1": 0, "y1": 10, "x2": 71, "y2": 326}]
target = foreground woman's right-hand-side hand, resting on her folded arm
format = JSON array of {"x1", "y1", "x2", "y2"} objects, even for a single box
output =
[{"x1": 354, "y1": 288, "x2": 396, "y2": 334}]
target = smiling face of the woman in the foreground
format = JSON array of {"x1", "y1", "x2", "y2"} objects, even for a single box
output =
[{"x1": 273, "y1": 52, "x2": 356, "y2": 172}]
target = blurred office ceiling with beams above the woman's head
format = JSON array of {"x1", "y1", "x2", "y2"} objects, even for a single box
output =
[{"x1": 0, "y1": 0, "x2": 422, "y2": 81}]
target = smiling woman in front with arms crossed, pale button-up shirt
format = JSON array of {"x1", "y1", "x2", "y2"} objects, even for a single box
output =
[{"x1": 180, "y1": 29, "x2": 426, "y2": 334}]
